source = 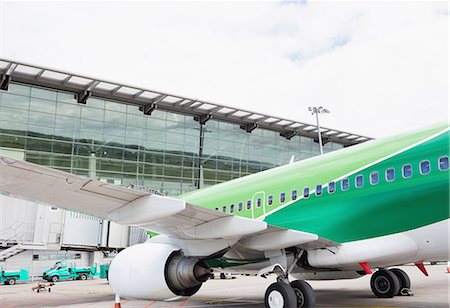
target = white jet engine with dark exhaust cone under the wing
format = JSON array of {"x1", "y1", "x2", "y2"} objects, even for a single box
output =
[{"x1": 108, "y1": 243, "x2": 211, "y2": 300}]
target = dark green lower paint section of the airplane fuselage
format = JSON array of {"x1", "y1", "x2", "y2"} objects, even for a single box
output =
[{"x1": 265, "y1": 132, "x2": 450, "y2": 242}]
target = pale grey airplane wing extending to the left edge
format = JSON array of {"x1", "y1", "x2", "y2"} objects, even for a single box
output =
[{"x1": 0, "y1": 156, "x2": 329, "y2": 251}]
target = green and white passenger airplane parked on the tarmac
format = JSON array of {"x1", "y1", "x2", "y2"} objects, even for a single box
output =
[{"x1": 0, "y1": 124, "x2": 450, "y2": 307}]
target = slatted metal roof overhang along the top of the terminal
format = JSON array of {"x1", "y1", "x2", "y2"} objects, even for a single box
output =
[{"x1": 0, "y1": 58, "x2": 372, "y2": 146}]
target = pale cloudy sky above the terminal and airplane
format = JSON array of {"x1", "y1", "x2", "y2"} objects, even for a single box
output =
[{"x1": 0, "y1": 0, "x2": 449, "y2": 138}]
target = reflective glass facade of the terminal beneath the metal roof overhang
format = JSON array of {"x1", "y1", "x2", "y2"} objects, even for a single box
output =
[{"x1": 0, "y1": 83, "x2": 342, "y2": 195}]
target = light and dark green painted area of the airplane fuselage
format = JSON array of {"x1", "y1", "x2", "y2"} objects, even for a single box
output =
[{"x1": 180, "y1": 125, "x2": 449, "y2": 242}]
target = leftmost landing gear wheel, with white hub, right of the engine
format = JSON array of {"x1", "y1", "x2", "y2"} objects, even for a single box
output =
[{"x1": 264, "y1": 282, "x2": 297, "y2": 308}]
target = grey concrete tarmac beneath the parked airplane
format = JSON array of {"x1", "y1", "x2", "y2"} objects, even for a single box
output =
[{"x1": 0, "y1": 265, "x2": 450, "y2": 308}]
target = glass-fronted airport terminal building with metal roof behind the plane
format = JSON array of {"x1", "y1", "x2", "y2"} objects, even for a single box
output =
[{"x1": 0, "y1": 59, "x2": 370, "y2": 276}]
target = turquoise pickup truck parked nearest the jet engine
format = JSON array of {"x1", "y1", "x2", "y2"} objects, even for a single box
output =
[{"x1": 42, "y1": 261, "x2": 98, "y2": 282}]
